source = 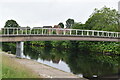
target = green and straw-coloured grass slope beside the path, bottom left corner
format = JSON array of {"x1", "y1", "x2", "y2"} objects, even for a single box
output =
[{"x1": 2, "y1": 54, "x2": 39, "y2": 78}]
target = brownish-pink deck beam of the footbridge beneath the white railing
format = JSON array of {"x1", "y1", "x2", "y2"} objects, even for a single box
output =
[{"x1": 0, "y1": 35, "x2": 120, "y2": 42}]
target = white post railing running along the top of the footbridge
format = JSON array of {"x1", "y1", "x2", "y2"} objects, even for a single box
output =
[{"x1": 2, "y1": 27, "x2": 120, "y2": 38}]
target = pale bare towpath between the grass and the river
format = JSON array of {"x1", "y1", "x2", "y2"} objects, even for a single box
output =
[{"x1": 3, "y1": 53, "x2": 86, "y2": 80}]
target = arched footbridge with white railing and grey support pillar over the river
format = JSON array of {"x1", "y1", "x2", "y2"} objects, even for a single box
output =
[{"x1": 0, "y1": 27, "x2": 120, "y2": 57}]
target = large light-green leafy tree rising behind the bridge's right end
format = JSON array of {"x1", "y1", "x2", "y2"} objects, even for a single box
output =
[{"x1": 85, "y1": 7, "x2": 120, "y2": 31}]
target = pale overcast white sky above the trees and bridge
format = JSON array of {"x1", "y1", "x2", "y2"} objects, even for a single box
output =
[{"x1": 0, "y1": 0, "x2": 120, "y2": 28}]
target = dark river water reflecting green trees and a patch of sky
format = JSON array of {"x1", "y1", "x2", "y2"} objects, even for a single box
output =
[{"x1": 24, "y1": 46, "x2": 120, "y2": 78}]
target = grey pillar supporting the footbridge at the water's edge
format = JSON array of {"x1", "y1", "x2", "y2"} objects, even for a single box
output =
[{"x1": 16, "y1": 42, "x2": 24, "y2": 58}]
